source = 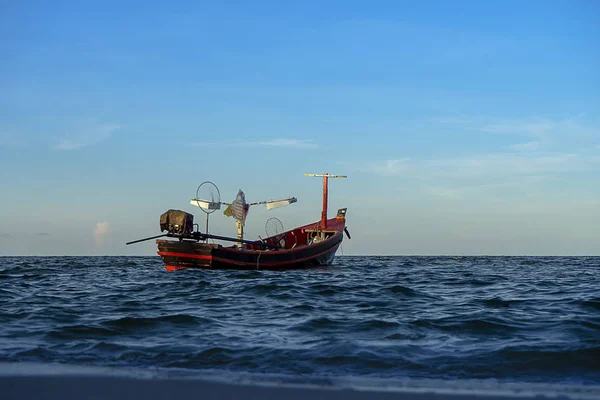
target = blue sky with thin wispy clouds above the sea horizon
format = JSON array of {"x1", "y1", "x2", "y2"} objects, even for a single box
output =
[{"x1": 0, "y1": 1, "x2": 600, "y2": 255}]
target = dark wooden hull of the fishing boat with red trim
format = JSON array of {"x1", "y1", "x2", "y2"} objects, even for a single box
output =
[{"x1": 156, "y1": 232, "x2": 343, "y2": 271}]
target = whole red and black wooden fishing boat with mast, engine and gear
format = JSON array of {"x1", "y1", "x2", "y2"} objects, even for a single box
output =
[{"x1": 127, "y1": 173, "x2": 350, "y2": 271}]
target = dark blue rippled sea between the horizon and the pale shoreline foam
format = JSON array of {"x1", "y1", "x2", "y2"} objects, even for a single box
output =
[{"x1": 0, "y1": 256, "x2": 600, "y2": 385}]
